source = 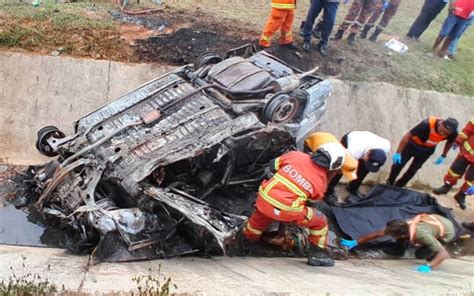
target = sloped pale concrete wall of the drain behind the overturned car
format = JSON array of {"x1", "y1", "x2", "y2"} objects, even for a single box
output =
[{"x1": 0, "y1": 52, "x2": 474, "y2": 186}]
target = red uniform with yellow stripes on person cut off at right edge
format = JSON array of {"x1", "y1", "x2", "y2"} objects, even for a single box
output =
[{"x1": 444, "y1": 119, "x2": 474, "y2": 192}]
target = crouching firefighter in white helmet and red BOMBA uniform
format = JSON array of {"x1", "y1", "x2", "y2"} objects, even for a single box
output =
[{"x1": 243, "y1": 135, "x2": 345, "y2": 266}]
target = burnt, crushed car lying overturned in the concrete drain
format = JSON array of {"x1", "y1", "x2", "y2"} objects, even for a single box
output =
[{"x1": 34, "y1": 46, "x2": 332, "y2": 261}]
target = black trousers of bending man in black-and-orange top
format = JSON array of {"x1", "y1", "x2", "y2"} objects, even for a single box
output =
[{"x1": 387, "y1": 142, "x2": 435, "y2": 187}]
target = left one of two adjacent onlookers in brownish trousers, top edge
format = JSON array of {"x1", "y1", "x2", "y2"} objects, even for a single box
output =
[{"x1": 334, "y1": 0, "x2": 388, "y2": 45}]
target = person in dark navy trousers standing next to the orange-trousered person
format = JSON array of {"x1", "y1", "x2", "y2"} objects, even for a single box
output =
[{"x1": 302, "y1": 0, "x2": 340, "y2": 56}]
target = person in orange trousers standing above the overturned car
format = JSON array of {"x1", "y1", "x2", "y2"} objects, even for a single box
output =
[{"x1": 259, "y1": 0, "x2": 296, "y2": 48}]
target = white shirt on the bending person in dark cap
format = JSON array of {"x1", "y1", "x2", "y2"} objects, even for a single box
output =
[{"x1": 347, "y1": 131, "x2": 390, "y2": 160}]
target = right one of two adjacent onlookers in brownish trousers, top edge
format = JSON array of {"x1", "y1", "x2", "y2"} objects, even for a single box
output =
[{"x1": 360, "y1": 0, "x2": 402, "y2": 42}]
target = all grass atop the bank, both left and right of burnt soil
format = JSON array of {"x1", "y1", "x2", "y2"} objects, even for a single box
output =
[{"x1": 0, "y1": 0, "x2": 474, "y2": 96}]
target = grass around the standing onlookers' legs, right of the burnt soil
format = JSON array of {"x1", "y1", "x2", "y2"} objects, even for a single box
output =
[{"x1": 167, "y1": 0, "x2": 474, "y2": 96}]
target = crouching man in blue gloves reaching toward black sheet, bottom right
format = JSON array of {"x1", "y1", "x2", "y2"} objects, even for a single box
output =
[{"x1": 341, "y1": 214, "x2": 456, "y2": 273}]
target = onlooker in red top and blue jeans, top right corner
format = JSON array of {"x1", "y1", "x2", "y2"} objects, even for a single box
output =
[{"x1": 433, "y1": 0, "x2": 474, "y2": 57}]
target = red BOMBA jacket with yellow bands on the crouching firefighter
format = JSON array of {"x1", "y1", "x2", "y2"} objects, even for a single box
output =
[{"x1": 258, "y1": 151, "x2": 327, "y2": 212}]
